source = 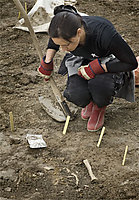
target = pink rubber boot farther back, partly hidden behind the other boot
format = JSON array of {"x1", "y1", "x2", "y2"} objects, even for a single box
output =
[{"x1": 81, "y1": 101, "x2": 93, "y2": 120}]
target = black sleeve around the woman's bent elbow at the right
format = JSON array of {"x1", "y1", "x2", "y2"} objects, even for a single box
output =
[{"x1": 106, "y1": 33, "x2": 138, "y2": 72}]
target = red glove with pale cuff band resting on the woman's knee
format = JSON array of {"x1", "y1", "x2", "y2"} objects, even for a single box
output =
[{"x1": 78, "y1": 59, "x2": 105, "y2": 80}]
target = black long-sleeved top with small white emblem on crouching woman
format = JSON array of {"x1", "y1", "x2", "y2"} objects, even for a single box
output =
[{"x1": 47, "y1": 16, "x2": 138, "y2": 72}]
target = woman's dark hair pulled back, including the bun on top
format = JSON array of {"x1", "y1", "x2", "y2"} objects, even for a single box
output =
[{"x1": 48, "y1": 5, "x2": 83, "y2": 41}]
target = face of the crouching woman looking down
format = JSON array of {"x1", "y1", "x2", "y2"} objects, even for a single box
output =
[{"x1": 52, "y1": 27, "x2": 81, "y2": 51}]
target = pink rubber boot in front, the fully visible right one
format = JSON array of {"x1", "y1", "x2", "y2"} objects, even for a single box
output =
[{"x1": 87, "y1": 104, "x2": 106, "y2": 131}]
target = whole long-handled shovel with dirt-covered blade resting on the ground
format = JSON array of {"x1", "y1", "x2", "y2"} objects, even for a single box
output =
[{"x1": 13, "y1": 0, "x2": 77, "y2": 122}]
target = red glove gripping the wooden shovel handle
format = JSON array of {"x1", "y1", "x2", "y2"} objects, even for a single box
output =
[{"x1": 38, "y1": 56, "x2": 53, "y2": 81}]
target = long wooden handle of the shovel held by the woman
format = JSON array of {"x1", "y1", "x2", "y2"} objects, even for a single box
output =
[{"x1": 13, "y1": 0, "x2": 71, "y2": 116}]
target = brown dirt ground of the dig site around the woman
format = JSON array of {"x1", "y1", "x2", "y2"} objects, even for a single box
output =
[{"x1": 0, "y1": 0, "x2": 139, "y2": 200}]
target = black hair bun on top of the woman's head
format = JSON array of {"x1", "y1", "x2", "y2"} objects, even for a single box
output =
[{"x1": 54, "y1": 5, "x2": 77, "y2": 15}]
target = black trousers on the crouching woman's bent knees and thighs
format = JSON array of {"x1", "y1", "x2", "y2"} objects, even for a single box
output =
[{"x1": 64, "y1": 72, "x2": 125, "y2": 108}]
